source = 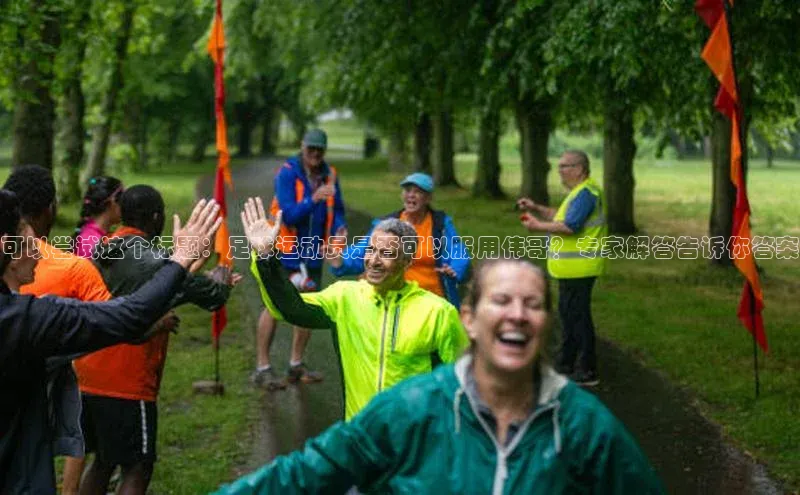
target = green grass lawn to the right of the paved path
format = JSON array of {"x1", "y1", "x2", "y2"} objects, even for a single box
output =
[{"x1": 324, "y1": 147, "x2": 800, "y2": 486}]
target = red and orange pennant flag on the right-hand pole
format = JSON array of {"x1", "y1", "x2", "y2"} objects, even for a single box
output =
[{"x1": 695, "y1": 0, "x2": 769, "y2": 352}]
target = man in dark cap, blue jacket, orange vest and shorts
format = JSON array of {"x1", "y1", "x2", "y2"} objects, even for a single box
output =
[{"x1": 251, "y1": 129, "x2": 347, "y2": 389}]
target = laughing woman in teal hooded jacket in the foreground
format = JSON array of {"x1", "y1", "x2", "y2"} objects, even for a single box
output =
[{"x1": 212, "y1": 260, "x2": 664, "y2": 495}]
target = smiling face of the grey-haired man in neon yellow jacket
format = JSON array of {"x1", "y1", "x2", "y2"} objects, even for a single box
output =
[{"x1": 364, "y1": 230, "x2": 409, "y2": 292}]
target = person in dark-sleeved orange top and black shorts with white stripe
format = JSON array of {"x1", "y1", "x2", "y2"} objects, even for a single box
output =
[{"x1": 75, "y1": 185, "x2": 241, "y2": 494}]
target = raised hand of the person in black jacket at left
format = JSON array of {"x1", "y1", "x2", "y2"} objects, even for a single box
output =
[{"x1": 170, "y1": 199, "x2": 222, "y2": 268}]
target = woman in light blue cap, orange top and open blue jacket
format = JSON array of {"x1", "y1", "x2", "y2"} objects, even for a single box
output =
[{"x1": 328, "y1": 172, "x2": 470, "y2": 308}]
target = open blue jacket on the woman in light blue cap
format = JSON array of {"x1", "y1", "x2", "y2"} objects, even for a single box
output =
[{"x1": 331, "y1": 210, "x2": 470, "y2": 308}]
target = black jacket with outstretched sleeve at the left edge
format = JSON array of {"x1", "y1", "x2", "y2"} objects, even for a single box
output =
[{"x1": 0, "y1": 261, "x2": 186, "y2": 494}]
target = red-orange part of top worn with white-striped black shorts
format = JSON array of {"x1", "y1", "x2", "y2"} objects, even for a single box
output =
[{"x1": 75, "y1": 226, "x2": 169, "y2": 402}]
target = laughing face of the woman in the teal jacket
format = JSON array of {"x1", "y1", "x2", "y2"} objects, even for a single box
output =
[{"x1": 462, "y1": 261, "x2": 549, "y2": 374}]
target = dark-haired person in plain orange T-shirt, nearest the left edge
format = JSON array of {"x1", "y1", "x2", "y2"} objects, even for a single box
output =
[{"x1": 3, "y1": 165, "x2": 121, "y2": 494}]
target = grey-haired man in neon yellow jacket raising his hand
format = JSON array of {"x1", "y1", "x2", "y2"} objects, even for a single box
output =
[{"x1": 242, "y1": 198, "x2": 469, "y2": 420}]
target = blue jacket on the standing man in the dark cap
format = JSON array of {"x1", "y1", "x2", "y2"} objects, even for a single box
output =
[{"x1": 274, "y1": 156, "x2": 346, "y2": 270}]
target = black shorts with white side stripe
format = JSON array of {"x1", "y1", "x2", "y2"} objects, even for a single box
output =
[{"x1": 81, "y1": 394, "x2": 158, "y2": 466}]
